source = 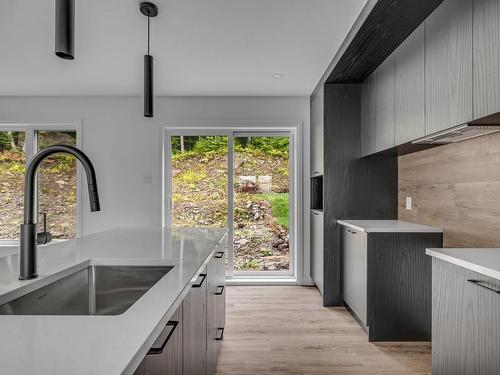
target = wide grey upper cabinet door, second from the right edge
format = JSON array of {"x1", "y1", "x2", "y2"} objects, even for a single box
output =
[{"x1": 425, "y1": 0, "x2": 473, "y2": 134}]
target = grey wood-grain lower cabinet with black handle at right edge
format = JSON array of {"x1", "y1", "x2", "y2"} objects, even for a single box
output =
[{"x1": 432, "y1": 258, "x2": 500, "y2": 375}]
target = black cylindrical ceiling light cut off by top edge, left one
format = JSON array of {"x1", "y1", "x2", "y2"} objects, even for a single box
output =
[{"x1": 55, "y1": 0, "x2": 75, "y2": 60}]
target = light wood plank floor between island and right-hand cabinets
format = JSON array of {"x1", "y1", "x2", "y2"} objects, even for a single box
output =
[{"x1": 217, "y1": 286, "x2": 431, "y2": 375}]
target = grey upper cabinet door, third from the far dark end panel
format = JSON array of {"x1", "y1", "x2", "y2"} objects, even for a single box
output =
[{"x1": 394, "y1": 24, "x2": 425, "y2": 145}]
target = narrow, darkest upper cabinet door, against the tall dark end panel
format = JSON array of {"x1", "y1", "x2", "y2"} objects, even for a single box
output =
[{"x1": 361, "y1": 72, "x2": 377, "y2": 156}]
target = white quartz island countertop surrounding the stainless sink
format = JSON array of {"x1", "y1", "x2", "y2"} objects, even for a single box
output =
[{"x1": 0, "y1": 228, "x2": 227, "y2": 375}]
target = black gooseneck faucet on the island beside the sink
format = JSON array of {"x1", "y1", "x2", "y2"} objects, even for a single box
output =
[{"x1": 19, "y1": 145, "x2": 101, "y2": 280}]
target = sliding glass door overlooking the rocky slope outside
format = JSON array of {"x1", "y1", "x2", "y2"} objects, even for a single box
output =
[{"x1": 165, "y1": 130, "x2": 294, "y2": 278}]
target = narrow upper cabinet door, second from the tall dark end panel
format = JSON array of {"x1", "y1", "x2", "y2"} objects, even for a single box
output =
[{"x1": 375, "y1": 55, "x2": 394, "y2": 152}]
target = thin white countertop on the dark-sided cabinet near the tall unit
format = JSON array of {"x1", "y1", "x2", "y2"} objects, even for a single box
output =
[{"x1": 337, "y1": 220, "x2": 443, "y2": 233}]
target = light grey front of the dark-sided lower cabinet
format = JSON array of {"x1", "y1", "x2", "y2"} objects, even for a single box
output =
[{"x1": 341, "y1": 227, "x2": 367, "y2": 326}]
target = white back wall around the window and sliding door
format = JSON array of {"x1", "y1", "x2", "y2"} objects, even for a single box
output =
[{"x1": 0, "y1": 96, "x2": 310, "y2": 282}]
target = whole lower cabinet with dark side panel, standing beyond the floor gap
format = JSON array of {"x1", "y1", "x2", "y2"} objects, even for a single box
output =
[{"x1": 341, "y1": 226, "x2": 443, "y2": 341}]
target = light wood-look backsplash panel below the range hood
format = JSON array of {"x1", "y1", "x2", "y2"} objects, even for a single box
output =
[{"x1": 398, "y1": 133, "x2": 500, "y2": 247}]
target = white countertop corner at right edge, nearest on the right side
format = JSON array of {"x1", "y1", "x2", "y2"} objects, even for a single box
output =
[{"x1": 426, "y1": 248, "x2": 500, "y2": 280}]
